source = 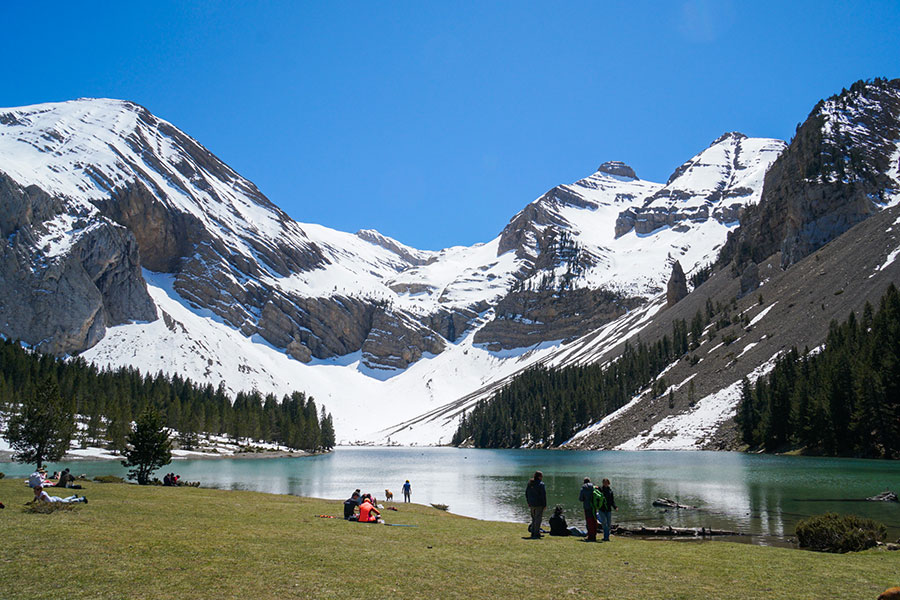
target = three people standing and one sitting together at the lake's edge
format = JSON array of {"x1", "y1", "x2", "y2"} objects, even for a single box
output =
[{"x1": 525, "y1": 471, "x2": 619, "y2": 542}]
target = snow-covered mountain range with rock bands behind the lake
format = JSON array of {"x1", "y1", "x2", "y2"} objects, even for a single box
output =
[{"x1": 0, "y1": 99, "x2": 796, "y2": 443}]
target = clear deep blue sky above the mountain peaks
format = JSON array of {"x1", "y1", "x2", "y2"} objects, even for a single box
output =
[{"x1": 0, "y1": 0, "x2": 900, "y2": 249}]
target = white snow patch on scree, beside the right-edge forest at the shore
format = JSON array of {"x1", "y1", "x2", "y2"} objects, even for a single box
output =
[{"x1": 616, "y1": 353, "x2": 780, "y2": 450}]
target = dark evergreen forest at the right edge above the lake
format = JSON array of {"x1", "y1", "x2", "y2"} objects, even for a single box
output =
[{"x1": 737, "y1": 284, "x2": 900, "y2": 458}]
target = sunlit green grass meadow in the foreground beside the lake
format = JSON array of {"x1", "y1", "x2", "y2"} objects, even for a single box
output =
[{"x1": 0, "y1": 478, "x2": 900, "y2": 600}]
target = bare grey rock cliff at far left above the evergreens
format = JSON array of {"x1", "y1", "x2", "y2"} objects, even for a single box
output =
[{"x1": 0, "y1": 173, "x2": 157, "y2": 354}]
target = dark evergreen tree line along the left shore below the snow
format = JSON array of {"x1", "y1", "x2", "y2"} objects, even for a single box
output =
[{"x1": 0, "y1": 340, "x2": 335, "y2": 451}]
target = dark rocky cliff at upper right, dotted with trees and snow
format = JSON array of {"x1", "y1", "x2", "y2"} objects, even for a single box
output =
[{"x1": 719, "y1": 79, "x2": 900, "y2": 272}]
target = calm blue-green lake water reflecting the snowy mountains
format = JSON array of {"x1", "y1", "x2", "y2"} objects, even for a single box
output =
[{"x1": 0, "y1": 447, "x2": 900, "y2": 543}]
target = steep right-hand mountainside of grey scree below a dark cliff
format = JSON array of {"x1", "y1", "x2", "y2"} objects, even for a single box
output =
[{"x1": 430, "y1": 80, "x2": 900, "y2": 449}]
